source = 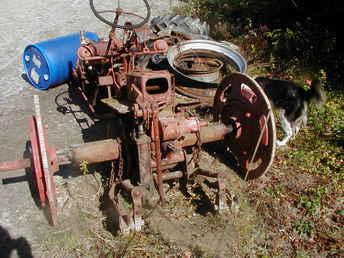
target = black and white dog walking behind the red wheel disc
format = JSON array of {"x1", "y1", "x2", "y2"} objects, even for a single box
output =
[{"x1": 255, "y1": 77, "x2": 326, "y2": 146}]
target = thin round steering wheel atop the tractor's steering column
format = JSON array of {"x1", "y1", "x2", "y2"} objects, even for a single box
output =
[{"x1": 90, "y1": 0, "x2": 151, "y2": 29}]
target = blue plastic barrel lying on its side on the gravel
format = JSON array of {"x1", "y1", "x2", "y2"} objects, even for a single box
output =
[{"x1": 23, "y1": 32, "x2": 99, "y2": 90}]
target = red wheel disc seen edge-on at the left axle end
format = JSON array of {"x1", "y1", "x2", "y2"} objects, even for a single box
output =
[{"x1": 30, "y1": 95, "x2": 57, "y2": 225}]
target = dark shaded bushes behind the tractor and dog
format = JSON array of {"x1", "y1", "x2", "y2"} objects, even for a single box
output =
[{"x1": 177, "y1": 0, "x2": 344, "y2": 88}]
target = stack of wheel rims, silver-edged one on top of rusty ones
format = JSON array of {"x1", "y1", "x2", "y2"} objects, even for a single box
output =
[{"x1": 167, "y1": 40, "x2": 247, "y2": 106}]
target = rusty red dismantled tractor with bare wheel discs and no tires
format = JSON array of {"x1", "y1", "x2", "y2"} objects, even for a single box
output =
[{"x1": 0, "y1": 0, "x2": 276, "y2": 233}]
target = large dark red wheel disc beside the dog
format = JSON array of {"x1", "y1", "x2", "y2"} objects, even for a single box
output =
[{"x1": 214, "y1": 73, "x2": 276, "y2": 179}]
